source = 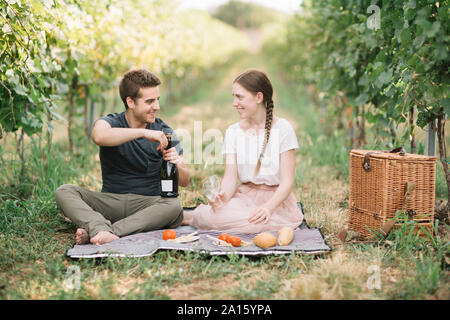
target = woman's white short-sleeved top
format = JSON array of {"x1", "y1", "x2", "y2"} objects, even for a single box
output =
[{"x1": 222, "y1": 118, "x2": 299, "y2": 186}]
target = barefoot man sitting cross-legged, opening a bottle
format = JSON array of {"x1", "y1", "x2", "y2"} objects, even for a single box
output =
[{"x1": 55, "y1": 70, "x2": 190, "y2": 244}]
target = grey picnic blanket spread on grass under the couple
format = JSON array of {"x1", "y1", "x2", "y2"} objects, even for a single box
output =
[{"x1": 66, "y1": 203, "x2": 331, "y2": 258}]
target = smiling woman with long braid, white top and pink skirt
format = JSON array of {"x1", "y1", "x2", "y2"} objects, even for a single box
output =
[{"x1": 183, "y1": 69, "x2": 303, "y2": 233}]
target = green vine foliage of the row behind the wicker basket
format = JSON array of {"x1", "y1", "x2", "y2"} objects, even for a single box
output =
[{"x1": 266, "y1": 0, "x2": 450, "y2": 142}]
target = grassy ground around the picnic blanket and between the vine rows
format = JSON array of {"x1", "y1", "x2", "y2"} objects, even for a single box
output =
[{"x1": 0, "y1": 52, "x2": 450, "y2": 300}]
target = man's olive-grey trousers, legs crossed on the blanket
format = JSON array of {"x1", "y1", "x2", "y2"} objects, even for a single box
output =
[{"x1": 55, "y1": 184, "x2": 183, "y2": 238}]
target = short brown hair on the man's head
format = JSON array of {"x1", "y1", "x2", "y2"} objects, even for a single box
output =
[{"x1": 119, "y1": 69, "x2": 161, "y2": 109}]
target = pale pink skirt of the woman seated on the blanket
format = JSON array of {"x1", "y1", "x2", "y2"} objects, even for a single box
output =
[{"x1": 190, "y1": 183, "x2": 303, "y2": 233}]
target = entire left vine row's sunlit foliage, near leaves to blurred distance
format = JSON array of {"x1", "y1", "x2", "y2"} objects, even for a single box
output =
[{"x1": 0, "y1": 0, "x2": 247, "y2": 135}]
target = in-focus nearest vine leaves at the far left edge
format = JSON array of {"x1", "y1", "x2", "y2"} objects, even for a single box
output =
[{"x1": 0, "y1": 0, "x2": 67, "y2": 134}]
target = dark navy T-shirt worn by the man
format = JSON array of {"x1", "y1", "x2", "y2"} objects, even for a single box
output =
[{"x1": 99, "y1": 112, "x2": 183, "y2": 196}]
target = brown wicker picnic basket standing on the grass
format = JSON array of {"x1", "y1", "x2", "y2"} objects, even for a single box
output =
[{"x1": 349, "y1": 148, "x2": 437, "y2": 238}]
